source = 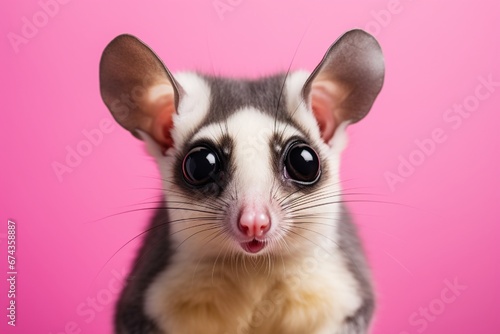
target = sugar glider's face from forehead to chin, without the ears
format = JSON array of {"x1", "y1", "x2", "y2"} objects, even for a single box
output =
[{"x1": 158, "y1": 72, "x2": 340, "y2": 255}]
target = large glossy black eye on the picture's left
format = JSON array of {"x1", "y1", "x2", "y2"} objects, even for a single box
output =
[{"x1": 182, "y1": 146, "x2": 220, "y2": 186}]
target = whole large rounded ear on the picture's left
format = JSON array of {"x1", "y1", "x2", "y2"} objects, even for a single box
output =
[{"x1": 99, "y1": 35, "x2": 183, "y2": 148}]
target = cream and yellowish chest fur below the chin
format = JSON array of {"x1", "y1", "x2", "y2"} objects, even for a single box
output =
[{"x1": 145, "y1": 245, "x2": 361, "y2": 334}]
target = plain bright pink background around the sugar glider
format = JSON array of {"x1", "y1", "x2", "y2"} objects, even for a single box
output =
[{"x1": 0, "y1": 0, "x2": 500, "y2": 334}]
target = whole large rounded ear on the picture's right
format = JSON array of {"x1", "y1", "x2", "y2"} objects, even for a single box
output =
[{"x1": 302, "y1": 30, "x2": 384, "y2": 142}]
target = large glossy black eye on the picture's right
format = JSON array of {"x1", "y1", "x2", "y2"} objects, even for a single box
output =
[{"x1": 285, "y1": 142, "x2": 321, "y2": 185}]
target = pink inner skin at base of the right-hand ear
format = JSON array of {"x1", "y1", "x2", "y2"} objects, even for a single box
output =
[{"x1": 311, "y1": 86, "x2": 338, "y2": 142}]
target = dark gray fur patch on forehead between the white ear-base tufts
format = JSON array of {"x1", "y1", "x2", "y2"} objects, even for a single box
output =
[{"x1": 203, "y1": 74, "x2": 290, "y2": 125}]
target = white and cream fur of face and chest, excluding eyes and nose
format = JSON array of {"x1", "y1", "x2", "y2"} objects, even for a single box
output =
[{"x1": 145, "y1": 72, "x2": 361, "y2": 334}]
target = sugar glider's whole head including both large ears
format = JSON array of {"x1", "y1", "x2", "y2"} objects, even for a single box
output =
[{"x1": 100, "y1": 30, "x2": 384, "y2": 257}]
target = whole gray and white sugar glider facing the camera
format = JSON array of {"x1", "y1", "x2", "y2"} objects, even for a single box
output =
[{"x1": 100, "y1": 30, "x2": 384, "y2": 334}]
